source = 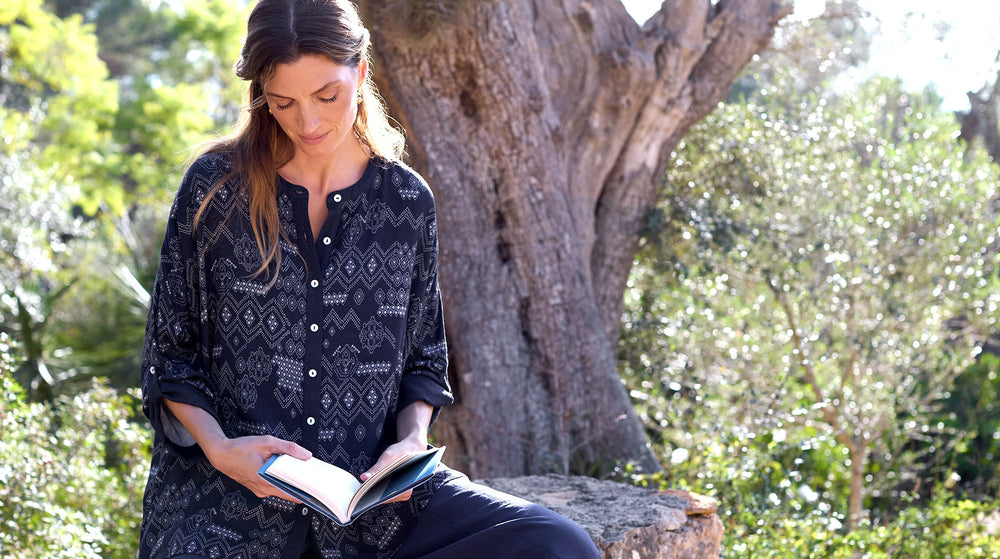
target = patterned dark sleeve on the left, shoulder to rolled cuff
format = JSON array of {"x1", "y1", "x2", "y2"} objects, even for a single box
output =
[{"x1": 141, "y1": 163, "x2": 218, "y2": 450}]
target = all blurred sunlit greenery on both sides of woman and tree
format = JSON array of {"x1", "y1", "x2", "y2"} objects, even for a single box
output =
[{"x1": 0, "y1": 0, "x2": 1000, "y2": 558}]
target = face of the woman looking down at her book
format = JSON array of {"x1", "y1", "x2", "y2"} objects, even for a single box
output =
[{"x1": 264, "y1": 54, "x2": 368, "y2": 157}]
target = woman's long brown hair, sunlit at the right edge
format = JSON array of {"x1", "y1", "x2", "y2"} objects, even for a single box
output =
[{"x1": 195, "y1": 0, "x2": 403, "y2": 281}]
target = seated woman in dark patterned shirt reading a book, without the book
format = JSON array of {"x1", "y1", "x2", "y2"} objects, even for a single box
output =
[{"x1": 139, "y1": 0, "x2": 598, "y2": 559}]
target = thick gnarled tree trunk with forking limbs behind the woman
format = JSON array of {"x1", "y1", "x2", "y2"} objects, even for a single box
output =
[{"x1": 362, "y1": 0, "x2": 788, "y2": 477}]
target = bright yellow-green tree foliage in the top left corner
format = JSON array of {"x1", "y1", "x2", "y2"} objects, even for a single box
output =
[{"x1": 0, "y1": 0, "x2": 241, "y2": 214}]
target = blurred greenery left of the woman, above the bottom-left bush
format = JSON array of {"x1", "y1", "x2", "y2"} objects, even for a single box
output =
[{"x1": 0, "y1": 0, "x2": 245, "y2": 399}]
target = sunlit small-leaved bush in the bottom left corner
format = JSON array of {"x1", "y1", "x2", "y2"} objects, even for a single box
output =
[{"x1": 0, "y1": 336, "x2": 149, "y2": 558}]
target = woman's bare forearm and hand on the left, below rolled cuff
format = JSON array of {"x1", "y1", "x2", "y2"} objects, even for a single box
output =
[{"x1": 163, "y1": 399, "x2": 312, "y2": 503}]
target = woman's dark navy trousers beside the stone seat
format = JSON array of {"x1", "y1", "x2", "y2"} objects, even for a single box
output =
[{"x1": 397, "y1": 475, "x2": 601, "y2": 559}]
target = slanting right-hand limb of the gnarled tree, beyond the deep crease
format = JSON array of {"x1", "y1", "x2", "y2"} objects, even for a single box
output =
[{"x1": 589, "y1": 0, "x2": 791, "y2": 342}]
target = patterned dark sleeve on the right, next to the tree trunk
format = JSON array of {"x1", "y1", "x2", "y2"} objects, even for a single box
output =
[{"x1": 398, "y1": 195, "x2": 454, "y2": 422}]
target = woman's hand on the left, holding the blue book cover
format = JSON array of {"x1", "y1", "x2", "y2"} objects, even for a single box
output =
[{"x1": 202, "y1": 435, "x2": 312, "y2": 503}]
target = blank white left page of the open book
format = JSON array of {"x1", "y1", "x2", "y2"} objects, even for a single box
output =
[{"x1": 267, "y1": 454, "x2": 361, "y2": 519}]
